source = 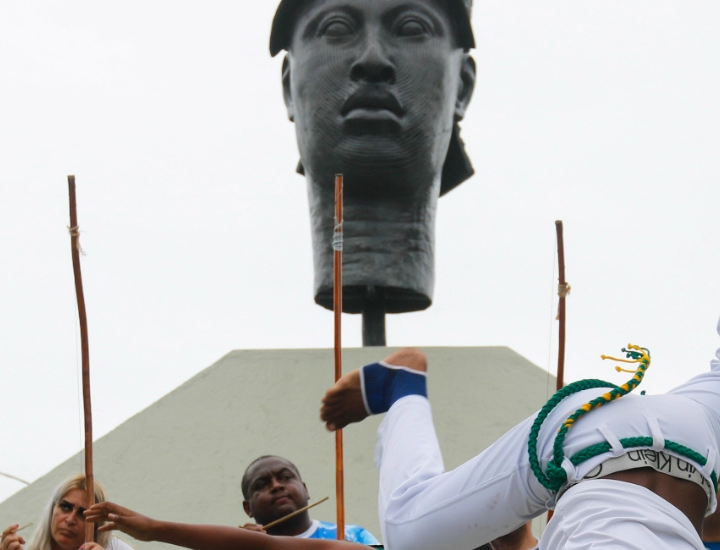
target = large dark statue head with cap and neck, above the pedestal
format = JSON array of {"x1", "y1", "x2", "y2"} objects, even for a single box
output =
[{"x1": 270, "y1": 0, "x2": 475, "y2": 322}]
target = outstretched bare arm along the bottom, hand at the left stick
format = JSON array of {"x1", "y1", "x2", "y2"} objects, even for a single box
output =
[{"x1": 85, "y1": 502, "x2": 367, "y2": 550}]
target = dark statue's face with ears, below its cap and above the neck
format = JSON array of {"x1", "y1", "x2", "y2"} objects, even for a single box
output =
[{"x1": 283, "y1": 0, "x2": 474, "y2": 196}]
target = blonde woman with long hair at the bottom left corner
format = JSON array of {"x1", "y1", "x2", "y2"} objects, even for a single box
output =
[{"x1": 0, "y1": 474, "x2": 132, "y2": 550}]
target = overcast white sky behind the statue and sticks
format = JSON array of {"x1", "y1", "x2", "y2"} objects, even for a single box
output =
[{"x1": 0, "y1": 0, "x2": 720, "y2": 506}]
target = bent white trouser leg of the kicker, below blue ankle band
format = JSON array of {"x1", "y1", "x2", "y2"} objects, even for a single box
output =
[{"x1": 376, "y1": 396, "x2": 551, "y2": 550}]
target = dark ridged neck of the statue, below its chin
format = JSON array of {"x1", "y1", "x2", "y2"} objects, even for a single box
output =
[{"x1": 308, "y1": 172, "x2": 439, "y2": 312}]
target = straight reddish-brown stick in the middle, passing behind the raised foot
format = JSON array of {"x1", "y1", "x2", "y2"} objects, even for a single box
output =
[{"x1": 333, "y1": 174, "x2": 345, "y2": 540}]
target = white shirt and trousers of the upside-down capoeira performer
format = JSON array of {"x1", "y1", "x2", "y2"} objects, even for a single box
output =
[{"x1": 375, "y1": 325, "x2": 720, "y2": 550}]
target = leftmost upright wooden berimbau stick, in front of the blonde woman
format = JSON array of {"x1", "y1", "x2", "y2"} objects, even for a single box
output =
[{"x1": 68, "y1": 176, "x2": 95, "y2": 542}]
